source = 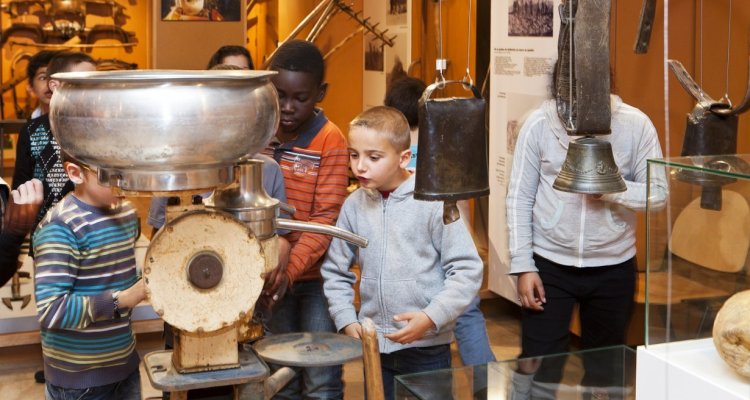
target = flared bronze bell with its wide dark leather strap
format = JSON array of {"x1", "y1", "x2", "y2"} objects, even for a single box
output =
[{"x1": 552, "y1": 0, "x2": 627, "y2": 194}]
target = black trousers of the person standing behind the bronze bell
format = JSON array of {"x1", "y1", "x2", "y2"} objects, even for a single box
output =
[{"x1": 521, "y1": 255, "x2": 636, "y2": 386}]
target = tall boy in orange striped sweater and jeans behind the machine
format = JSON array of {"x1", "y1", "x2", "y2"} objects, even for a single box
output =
[{"x1": 264, "y1": 40, "x2": 349, "y2": 399}]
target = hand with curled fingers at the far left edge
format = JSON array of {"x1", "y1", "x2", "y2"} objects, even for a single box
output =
[{"x1": 3, "y1": 179, "x2": 44, "y2": 235}]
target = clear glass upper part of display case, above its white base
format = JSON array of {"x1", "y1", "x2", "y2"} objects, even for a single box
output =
[{"x1": 640, "y1": 155, "x2": 750, "y2": 346}]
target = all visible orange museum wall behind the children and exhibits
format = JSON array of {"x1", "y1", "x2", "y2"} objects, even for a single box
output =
[{"x1": 0, "y1": 0, "x2": 750, "y2": 276}]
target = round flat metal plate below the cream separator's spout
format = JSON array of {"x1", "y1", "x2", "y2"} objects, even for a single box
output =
[{"x1": 253, "y1": 332, "x2": 362, "y2": 367}]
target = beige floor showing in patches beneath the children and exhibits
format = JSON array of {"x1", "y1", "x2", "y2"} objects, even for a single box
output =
[{"x1": 0, "y1": 299, "x2": 520, "y2": 400}]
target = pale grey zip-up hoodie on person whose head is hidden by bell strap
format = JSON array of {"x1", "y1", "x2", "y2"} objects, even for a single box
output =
[{"x1": 506, "y1": 95, "x2": 667, "y2": 274}]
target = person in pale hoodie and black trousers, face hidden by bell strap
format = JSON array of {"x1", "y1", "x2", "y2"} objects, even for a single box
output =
[{"x1": 506, "y1": 76, "x2": 666, "y2": 390}]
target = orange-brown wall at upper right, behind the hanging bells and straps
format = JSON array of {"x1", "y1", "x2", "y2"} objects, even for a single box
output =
[{"x1": 612, "y1": 0, "x2": 750, "y2": 269}]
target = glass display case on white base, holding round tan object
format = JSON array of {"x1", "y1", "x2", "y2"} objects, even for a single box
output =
[{"x1": 638, "y1": 155, "x2": 750, "y2": 400}]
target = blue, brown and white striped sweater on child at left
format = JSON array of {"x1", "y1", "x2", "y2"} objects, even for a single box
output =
[{"x1": 33, "y1": 194, "x2": 140, "y2": 389}]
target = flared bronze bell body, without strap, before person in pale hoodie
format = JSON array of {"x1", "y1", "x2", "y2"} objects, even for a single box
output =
[{"x1": 552, "y1": 137, "x2": 627, "y2": 194}]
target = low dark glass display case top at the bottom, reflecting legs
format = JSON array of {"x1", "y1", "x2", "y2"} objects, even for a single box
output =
[{"x1": 395, "y1": 346, "x2": 636, "y2": 400}]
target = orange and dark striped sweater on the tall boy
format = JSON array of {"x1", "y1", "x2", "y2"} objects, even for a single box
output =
[{"x1": 263, "y1": 110, "x2": 349, "y2": 285}]
